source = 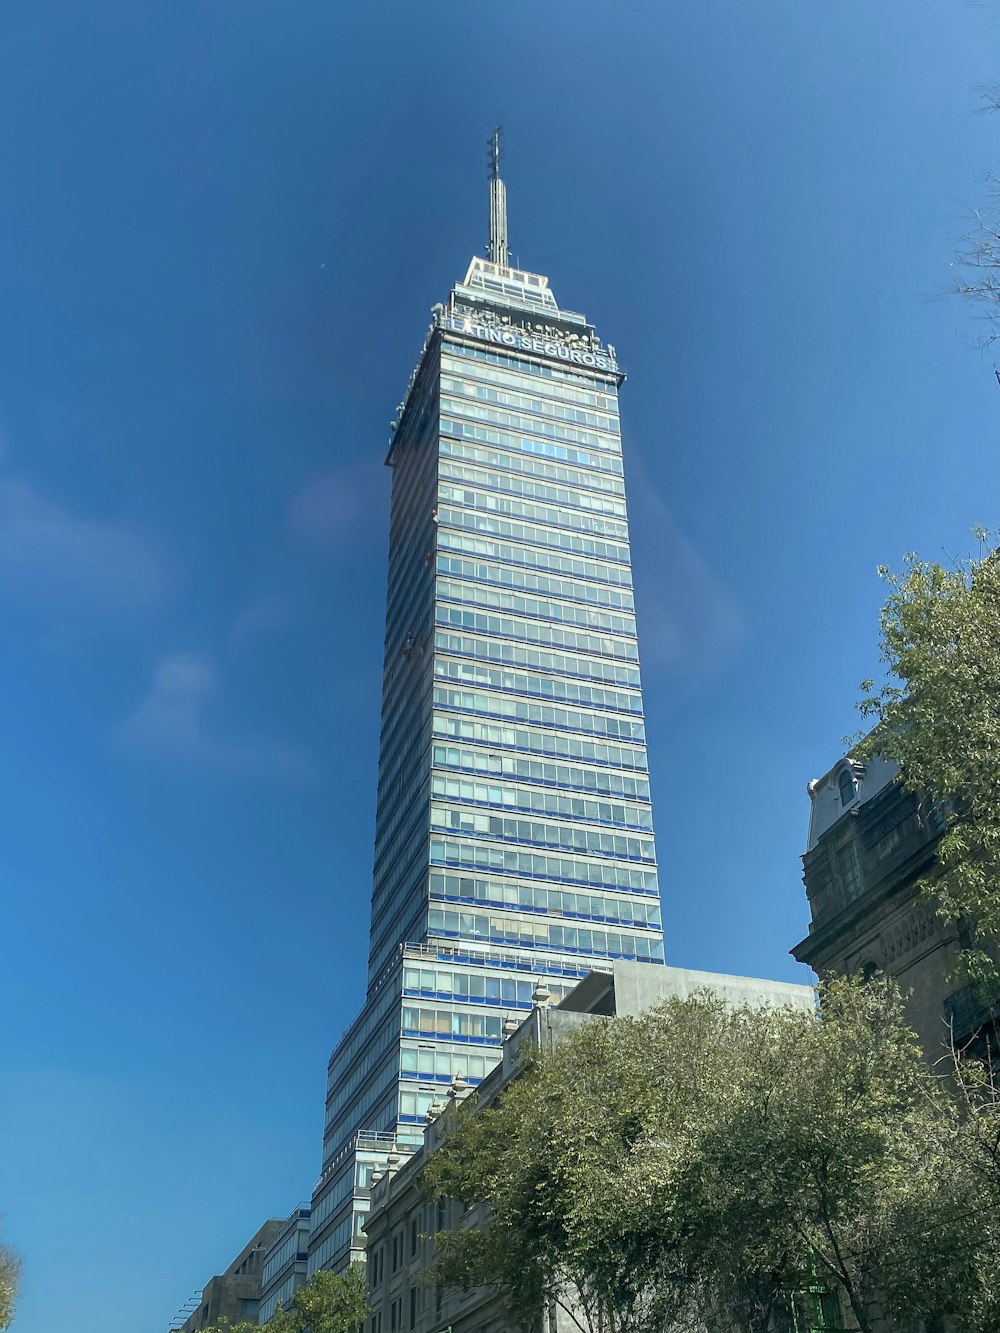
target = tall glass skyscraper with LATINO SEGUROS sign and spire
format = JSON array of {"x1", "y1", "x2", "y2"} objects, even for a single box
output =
[{"x1": 308, "y1": 133, "x2": 663, "y2": 1272}]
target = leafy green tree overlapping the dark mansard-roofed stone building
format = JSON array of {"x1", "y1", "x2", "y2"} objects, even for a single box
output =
[{"x1": 856, "y1": 532, "x2": 1000, "y2": 978}]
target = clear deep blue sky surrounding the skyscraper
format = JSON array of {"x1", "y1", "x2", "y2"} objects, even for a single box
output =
[{"x1": 0, "y1": 0, "x2": 1000, "y2": 1333}]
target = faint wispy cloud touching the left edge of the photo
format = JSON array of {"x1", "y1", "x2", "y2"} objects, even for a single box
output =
[{"x1": 0, "y1": 476, "x2": 176, "y2": 613}]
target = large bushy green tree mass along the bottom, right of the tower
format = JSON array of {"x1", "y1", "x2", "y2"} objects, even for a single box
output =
[{"x1": 425, "y1": 981, "x2": 992, "y2": 1333}]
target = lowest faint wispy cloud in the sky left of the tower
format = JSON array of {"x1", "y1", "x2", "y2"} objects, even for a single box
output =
[{"x1": 117, "y1": 653, "x2": 316, "y2": 785}]
